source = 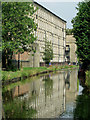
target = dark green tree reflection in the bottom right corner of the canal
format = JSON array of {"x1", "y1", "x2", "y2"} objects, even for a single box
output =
[{"x1": 74, "y1": 89, "x2": 90, "y2": 120}]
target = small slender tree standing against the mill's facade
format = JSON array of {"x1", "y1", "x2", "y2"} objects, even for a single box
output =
[{"x1": 43, "y1": 40, "x2": 53, "y2": 65}]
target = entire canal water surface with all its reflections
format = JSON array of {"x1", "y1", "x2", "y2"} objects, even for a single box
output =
[{"x1": 2, "y1": 69, "x2": 90, "y2": 120}]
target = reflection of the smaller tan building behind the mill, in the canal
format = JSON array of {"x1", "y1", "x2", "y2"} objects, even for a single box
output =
[{"x1": 65, "y1": 70, "x2": 78, "y2": 103}]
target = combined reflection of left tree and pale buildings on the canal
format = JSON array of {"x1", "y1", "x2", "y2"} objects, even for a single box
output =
[{"x1": 3, "y1": 70, "x2": 77, "y2": 118}]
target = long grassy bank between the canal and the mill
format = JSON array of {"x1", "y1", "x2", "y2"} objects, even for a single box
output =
[{"x1": 2, "y1": 65, "x2": 77, "y2": 81}]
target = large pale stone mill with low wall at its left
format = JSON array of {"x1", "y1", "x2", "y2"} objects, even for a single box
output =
[{"x1": 14, "y1": 2, "x2": 66, "y2": 67}]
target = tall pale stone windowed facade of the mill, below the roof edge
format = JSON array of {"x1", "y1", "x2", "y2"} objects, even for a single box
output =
[{"x1": 34, "y1": 3, "x2": 66, "y2": 63}]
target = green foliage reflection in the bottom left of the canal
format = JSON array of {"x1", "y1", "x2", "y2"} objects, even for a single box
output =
[{"x1": 4, "y1": 96, "x2": 37, "y2": 119}]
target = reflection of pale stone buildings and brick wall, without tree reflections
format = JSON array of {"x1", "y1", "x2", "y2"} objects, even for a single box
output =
[{"x1": 4, "y1": 71, "x2": 77, "y2": 118}]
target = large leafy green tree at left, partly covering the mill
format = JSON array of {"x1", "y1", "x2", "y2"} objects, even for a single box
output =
[{"x1": 2, "y1": 2, "x2": 37, "y2": 67}]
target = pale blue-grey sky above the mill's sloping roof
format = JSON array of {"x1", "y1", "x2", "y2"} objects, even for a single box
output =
[{"x1": 35, "y1": 0, "x2": 82, "y2": 28}]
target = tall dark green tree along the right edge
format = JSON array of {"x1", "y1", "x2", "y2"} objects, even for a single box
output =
[{"x1": 72, "y1": 1, "x2": 90, "y2": 69}]
